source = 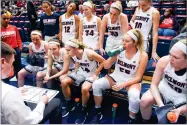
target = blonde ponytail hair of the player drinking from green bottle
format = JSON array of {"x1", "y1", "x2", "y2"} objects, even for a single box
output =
[{"x1": 128, "y1": 29, "x2": 144, "y2": 52}]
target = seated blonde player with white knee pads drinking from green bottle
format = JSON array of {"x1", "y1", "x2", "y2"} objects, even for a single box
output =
[{"x1": 91, "y1": 29, "x2": 148, "y2": 124}]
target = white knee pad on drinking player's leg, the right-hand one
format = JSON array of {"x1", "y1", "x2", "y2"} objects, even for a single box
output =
[{"x1": 128, "y1": 88, "x2": 140, "y2": 113}]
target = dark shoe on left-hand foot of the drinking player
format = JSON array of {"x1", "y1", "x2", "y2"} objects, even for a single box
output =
[{"x1": 90, "y1": 109, "x2": 103, "y2": 124}]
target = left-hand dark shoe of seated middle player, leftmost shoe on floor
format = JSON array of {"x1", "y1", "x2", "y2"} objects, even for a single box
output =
[{"x1": 62, "y1": 100, "x2": 75, "y2": 118}]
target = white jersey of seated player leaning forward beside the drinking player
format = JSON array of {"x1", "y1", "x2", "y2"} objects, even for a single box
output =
[{"x1": 74, "y1": 49, "x2": 97, "y2": 77}]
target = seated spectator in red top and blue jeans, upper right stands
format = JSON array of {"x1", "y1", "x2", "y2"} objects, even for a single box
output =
[{"x1": 158, "y1": 8, "x2": 179, "y2": 37}]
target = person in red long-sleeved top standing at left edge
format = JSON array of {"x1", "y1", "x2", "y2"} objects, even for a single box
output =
[{"x1": 1, "y1": 11, "x2": 22, "y2": 80}]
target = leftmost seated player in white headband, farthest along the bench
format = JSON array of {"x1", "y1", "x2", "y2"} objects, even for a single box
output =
[{"x1": 18, "y1": 30, "x2": 48, "y2": 87}]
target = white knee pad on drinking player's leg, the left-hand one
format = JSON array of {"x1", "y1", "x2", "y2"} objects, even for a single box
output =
[{"x1": 92, "y1": 77, "x2": 110, "y2": 96}]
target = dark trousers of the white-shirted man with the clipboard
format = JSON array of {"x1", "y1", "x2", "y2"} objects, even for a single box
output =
[{"x1": 27, "y1": 98, "x2": 62, "y2": 124}]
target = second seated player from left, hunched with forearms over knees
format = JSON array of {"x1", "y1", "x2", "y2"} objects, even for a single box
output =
[{"x1": 36, "y1": 39, "x2": 74, "y2": 88}]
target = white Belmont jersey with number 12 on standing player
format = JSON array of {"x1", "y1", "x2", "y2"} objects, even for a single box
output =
[{"x1": 62, "y1": 14, "x2": 76, "y2": 42}]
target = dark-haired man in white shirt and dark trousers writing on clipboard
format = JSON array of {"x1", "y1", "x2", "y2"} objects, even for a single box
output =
[{"x1": 0, "y1": 42, "x2": 62, "y2": 124}]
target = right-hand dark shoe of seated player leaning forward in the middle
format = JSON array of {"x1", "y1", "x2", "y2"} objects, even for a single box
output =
[{"x1": 75, "y1": 107, "x2": 88, "y2": 124}]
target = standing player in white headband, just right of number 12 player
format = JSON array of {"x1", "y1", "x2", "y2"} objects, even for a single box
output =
[{"x1": 79, "y1": 2, "x2": 101, "y2": 50}]
